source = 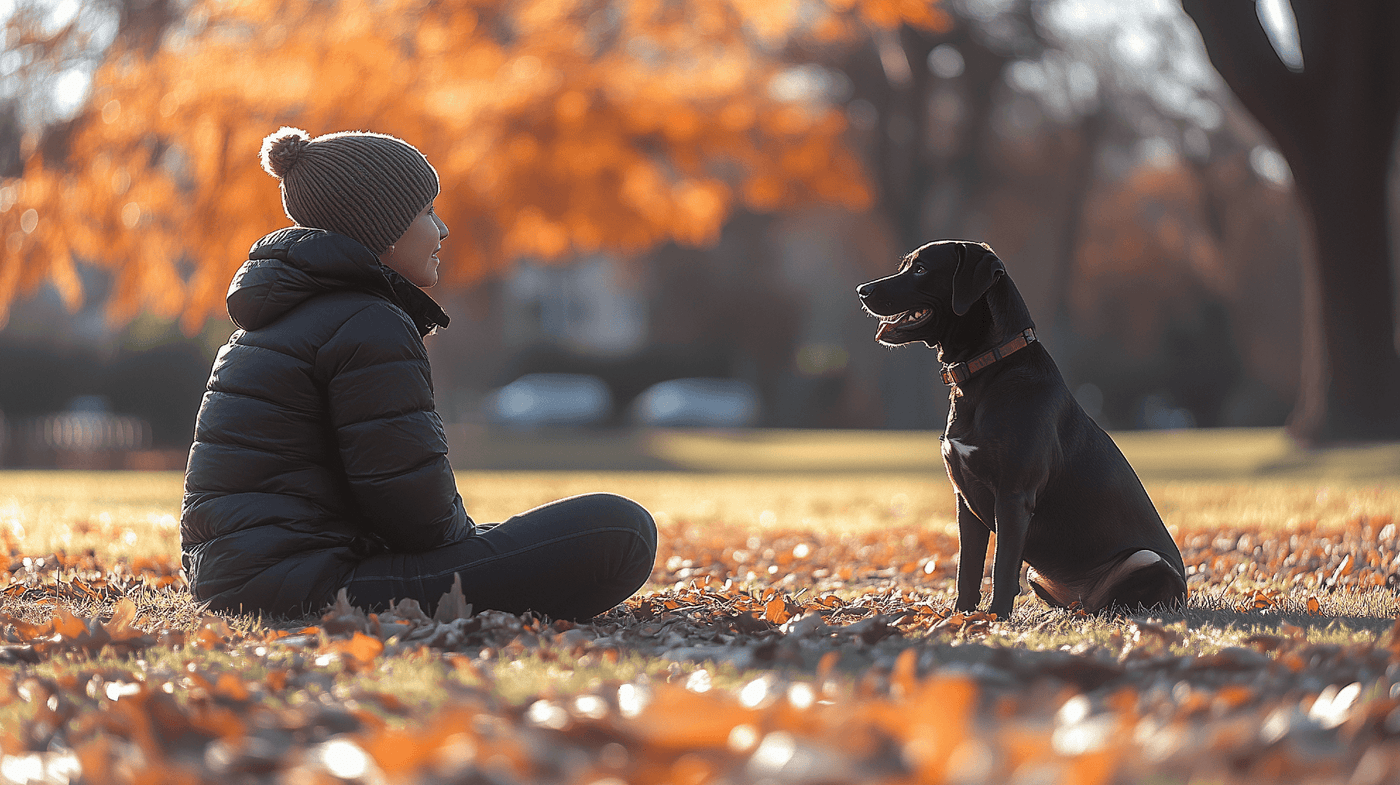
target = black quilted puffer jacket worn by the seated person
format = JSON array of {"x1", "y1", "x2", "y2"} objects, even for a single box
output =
[{"x1": 181, "y1": 228, "x2": 473, "y2": 614}]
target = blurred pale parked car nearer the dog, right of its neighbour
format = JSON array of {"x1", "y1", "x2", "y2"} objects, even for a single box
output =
[{"x1": 630, "y1": 376, "x2": 759, "y2": 428}]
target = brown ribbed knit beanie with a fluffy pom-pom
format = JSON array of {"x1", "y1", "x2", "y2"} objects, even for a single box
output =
[{"x1": 262, "y1": 126, "x2": 440, "y2": 256}]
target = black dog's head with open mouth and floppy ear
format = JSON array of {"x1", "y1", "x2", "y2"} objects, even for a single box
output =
[{"x1": 855, "y1": 239, "x2": 1007, "y2": 347}]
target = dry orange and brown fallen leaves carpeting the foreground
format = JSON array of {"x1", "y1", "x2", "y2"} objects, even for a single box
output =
[{"x1": 0, "y1": 519, "x2": 1400, "y2": 785}]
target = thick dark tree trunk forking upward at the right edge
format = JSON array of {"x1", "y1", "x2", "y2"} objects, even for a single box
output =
[{"x1": 1183, "y1": 0, "x2": 1400, "y2": 442}]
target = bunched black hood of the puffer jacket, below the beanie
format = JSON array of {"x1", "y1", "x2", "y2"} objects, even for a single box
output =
[{"x1": 227, "y1": 227, "x2": 448, "y2": 334}]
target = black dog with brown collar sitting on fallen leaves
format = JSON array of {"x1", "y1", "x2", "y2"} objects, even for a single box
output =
[{"x1": 855, "y1": 241, "x2": 1186, "y2": 618}]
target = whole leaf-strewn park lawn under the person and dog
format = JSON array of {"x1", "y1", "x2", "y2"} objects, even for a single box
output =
[{"x1": 0, "y1": 431, "x2": 1400, "y2": 784}]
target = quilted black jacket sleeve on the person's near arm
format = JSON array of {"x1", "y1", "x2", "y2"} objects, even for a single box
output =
[{"x1": 316, "y1": 302, "x2": 475, "y2": 551}]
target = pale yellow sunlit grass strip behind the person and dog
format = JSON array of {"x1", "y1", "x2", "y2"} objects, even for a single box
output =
[{"x1": 0, "y1": 472, "x2": 1400, "y2": 558}]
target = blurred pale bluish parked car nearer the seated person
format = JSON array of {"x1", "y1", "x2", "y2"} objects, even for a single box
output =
[{"x1": 483, "y1": 374, "x2": 613, "y2": 428}]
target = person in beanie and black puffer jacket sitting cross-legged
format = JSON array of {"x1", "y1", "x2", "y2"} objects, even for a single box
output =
[{"x1": 181, "y1": 127, "x2": 657, "y2": 618}]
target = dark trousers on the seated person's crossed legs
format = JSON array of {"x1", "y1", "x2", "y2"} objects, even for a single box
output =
[{"x1": 346, "y1": 494, "x2": 657, "y2": 618}]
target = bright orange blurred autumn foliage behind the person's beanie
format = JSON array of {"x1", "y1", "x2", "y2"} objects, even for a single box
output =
[{"x1": 0, "y1": 0, "x2": 945, "y2": 327}]
